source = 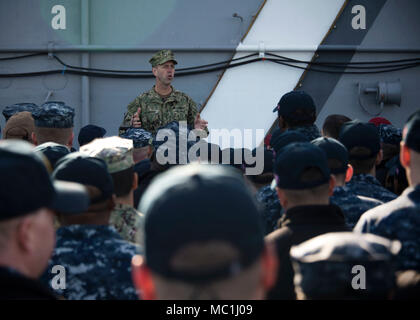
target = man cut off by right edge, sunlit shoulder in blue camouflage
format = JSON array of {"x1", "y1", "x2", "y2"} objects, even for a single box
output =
[{"x1": 354, "y1": 111, "x2": 420, "y2": 270}]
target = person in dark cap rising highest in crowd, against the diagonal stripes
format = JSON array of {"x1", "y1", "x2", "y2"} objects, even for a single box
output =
[{"x1": 273, "y1": 91, "x2": 321, "y2": 141}]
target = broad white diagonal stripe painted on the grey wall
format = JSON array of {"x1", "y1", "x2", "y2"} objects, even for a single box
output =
[{"x1": 201, "y1": 0, "x2": 344, "y2": 148}]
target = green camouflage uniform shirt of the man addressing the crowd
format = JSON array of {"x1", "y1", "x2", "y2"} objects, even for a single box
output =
[{"x1": 119, "y1": 86, "x2": 197, "y2": 135}]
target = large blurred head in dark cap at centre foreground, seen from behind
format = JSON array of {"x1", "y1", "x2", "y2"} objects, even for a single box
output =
[{"x1": 133, "y1": 163, "x2": 277, "y2": 300}]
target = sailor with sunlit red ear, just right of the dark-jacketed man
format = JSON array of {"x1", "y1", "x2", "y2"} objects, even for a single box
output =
[{"x1": 312, "y1": 137, "x2": 382, "y2": 229}]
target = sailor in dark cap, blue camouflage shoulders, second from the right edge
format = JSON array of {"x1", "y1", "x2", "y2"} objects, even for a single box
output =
[{"x1": 339, "y1": 120, "x2": 397, "y2": 202}]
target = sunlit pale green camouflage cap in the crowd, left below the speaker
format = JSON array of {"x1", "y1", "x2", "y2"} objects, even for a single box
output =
[{"x1": 80, "y1": 137, "x2": 134, "y2": 173}]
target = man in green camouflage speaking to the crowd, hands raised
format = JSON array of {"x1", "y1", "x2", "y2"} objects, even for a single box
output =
[{"x1": 119, "y1": 50, "x2": 207, "y2": 135}]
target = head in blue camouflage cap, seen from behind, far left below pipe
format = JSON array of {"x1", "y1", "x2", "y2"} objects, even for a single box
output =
[{"x1": 32, "y1": 101, "x2": 75, "y2": 149}]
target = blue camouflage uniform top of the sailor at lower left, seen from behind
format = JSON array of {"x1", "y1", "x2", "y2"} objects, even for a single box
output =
[{"x1": 41, "y1": 225, "x2": 142, "y2": 300}]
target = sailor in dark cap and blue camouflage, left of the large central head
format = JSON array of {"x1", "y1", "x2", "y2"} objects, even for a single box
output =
[{"x1": 42, "y1": 152, "x2": 141, "y2": 300}]
